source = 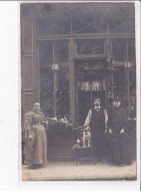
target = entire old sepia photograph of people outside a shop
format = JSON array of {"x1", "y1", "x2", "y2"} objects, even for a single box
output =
[{"x1": 19, "y1": 1, "x2": 137, "y2": 181}]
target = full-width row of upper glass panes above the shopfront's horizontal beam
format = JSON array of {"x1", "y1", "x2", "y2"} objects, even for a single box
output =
[{"x1": 37, "y1": 3, "x2": 135, "y2": 35}]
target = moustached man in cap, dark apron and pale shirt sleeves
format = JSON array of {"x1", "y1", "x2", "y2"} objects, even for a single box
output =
[{"x1": 84, "y1": 97, "x2": 108, "y2": 161}]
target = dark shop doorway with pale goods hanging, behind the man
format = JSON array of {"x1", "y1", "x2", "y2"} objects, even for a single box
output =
[{"x1": 74, "y1": 59, "x2": 107, "y2": 126}]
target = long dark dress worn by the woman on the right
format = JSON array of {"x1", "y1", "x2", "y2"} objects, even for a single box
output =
[{"x1": 109, "y1": 107, "x2": 129, "y2": 165}]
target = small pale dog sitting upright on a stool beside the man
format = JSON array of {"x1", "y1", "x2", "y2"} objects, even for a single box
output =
[{"x1": 77, "y1": 125, "x2": 91, "y2": 147}]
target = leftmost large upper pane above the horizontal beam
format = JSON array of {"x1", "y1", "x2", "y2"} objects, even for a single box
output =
[{"x1": 39, "y1": 4, "x2": 71, "y2": 35}]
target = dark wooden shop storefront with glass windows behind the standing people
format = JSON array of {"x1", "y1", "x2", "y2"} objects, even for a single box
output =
[{"x1": 21, "y1": 3, "x2": 136, "y2": 158}]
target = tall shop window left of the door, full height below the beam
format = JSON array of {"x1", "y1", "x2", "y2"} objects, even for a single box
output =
[{"x1": 39, "y1": 40, "x2": 70, "y2": 119}]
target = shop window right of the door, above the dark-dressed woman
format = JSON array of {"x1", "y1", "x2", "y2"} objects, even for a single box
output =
[{"x1": 112, "y1": 39, "x2": 136, "y2": 112}]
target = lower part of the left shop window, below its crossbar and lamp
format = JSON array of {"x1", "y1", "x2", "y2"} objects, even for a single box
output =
[{"x1": 40, "y1": 67, "x2": 70, "y2": 119}]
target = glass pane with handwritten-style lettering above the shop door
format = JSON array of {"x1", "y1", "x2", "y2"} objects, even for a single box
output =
[{"x1": 76, "y1": 39, "x2": 104, "y2": 55}]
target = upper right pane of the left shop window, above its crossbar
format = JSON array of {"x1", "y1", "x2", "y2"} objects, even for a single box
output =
[{"x1": 54, "y1": 40, "x2": 68, "y2": 63}]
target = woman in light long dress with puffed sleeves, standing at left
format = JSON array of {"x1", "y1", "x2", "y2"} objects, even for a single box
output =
[{"x1": 24, "y1": 103, "x2": 47, "y2": 168}]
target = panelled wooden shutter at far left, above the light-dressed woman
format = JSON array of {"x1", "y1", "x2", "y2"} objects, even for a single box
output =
[{"x1": 21, "y1": 5, "x2": 39, "y2": 129}]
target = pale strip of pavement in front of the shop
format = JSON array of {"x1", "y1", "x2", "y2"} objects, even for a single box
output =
[{"x1": 22, "y1": 161, "x2": 136, "y2": 181}]
